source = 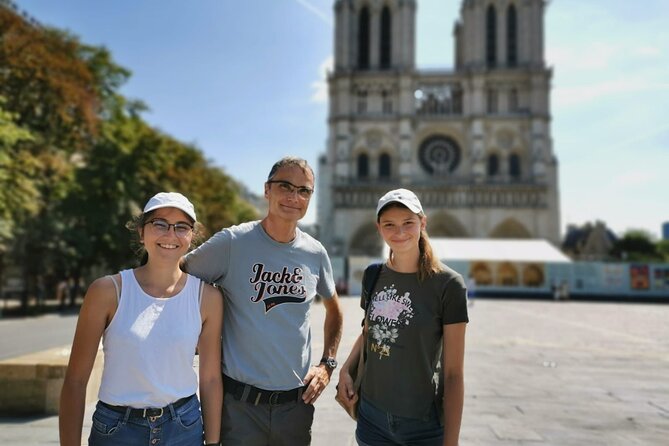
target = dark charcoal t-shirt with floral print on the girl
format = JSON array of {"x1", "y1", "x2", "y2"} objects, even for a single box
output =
[{"x1": 362, "y1": 265, "x2": 469, "y2": 419}]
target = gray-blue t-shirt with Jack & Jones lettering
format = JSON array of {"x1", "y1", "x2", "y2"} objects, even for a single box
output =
[{"x1": 185, "y1": 221, "x2": 335, "y2": 390}]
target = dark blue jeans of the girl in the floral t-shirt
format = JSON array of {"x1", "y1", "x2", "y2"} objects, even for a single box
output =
[{"x1": 355, "y1": 398, "x2": 444, "y2": 446}]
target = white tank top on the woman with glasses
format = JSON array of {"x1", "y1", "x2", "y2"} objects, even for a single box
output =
[{"x1": 98, "y1": 269, "x2": 202, "y2": 409}]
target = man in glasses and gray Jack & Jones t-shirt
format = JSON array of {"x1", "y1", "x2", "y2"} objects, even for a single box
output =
[{"x1": 184, "y1": 157, "x2": 342, "y2": 446}]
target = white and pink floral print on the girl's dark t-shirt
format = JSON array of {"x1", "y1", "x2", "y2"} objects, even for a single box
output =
[{"x1": 369, "y1": 284, "x2": 414, "y2": 359}]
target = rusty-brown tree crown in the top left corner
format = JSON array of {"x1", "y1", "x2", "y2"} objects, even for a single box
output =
[{"x1": 0, "y1": 7, "x2": 100, "y2": 153}]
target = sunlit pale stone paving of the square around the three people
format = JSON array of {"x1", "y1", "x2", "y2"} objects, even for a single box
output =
[{"x1": 0, "y1": 298, "x2": 669, "y2": 446}]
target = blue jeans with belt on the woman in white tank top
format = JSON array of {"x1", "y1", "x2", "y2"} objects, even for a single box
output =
[{"x1": 88, "y1": 396, "x2": 204, "y2": 446}]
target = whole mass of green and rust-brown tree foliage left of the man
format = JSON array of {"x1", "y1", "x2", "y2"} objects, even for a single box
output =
[{"x1": 0, "y1": 4, "x2": 256, "y2": 306}]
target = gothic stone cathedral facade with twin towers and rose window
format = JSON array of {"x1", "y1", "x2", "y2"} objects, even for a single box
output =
[{"x1": 318, "y1": 0, "x2": 560, "y2": 256}]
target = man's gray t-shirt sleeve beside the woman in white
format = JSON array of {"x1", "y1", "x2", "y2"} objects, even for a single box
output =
[{"x1": 184, "y1": 229, "x2": 232, "y2": 284}]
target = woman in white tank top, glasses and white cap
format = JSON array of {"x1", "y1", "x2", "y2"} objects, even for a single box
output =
[{"x1": 59, "y1": 192, "x2": 223, "y2": 446}]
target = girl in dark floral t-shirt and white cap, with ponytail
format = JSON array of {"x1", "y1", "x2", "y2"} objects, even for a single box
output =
[{"x1": 338, "y1": 189, "x2": 469, "y2": 446}]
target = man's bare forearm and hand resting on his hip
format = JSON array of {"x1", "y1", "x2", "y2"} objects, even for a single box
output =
[{"x1": 302, "y1": 292, "x2": 344, "y2": 404}]
